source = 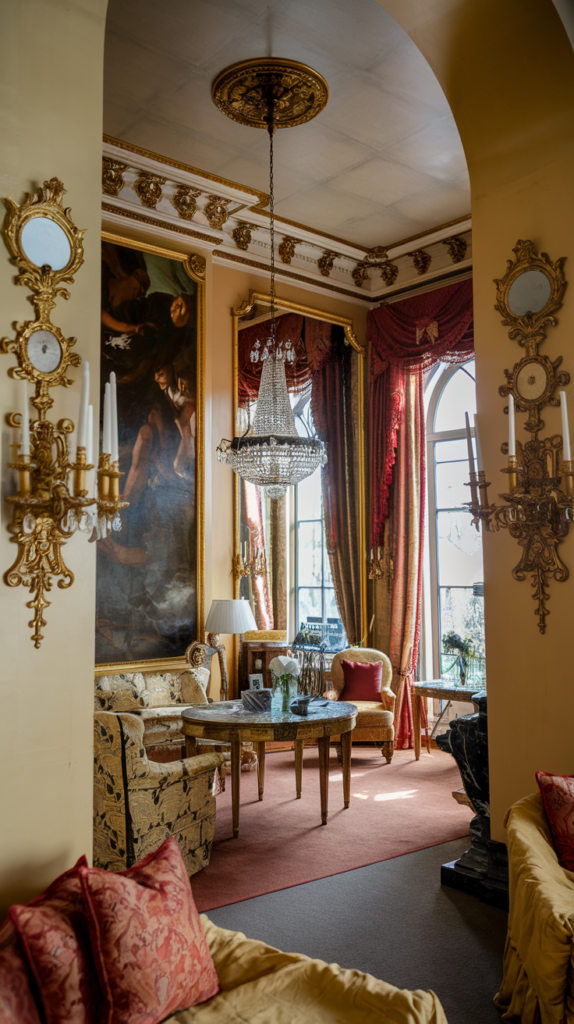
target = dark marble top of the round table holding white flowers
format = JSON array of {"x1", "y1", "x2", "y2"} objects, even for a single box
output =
[{"x1": 181, "y1": 699, "x2": 357, "y2": 728}]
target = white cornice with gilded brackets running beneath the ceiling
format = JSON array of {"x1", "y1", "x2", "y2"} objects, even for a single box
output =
[{"x1": 102, "y1": 138, "x2": 472, "y2": 306}]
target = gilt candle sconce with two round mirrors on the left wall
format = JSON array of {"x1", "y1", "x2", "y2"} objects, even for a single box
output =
[{"x1": 0, "y1": 178, "x2": 128, "y2": 647}]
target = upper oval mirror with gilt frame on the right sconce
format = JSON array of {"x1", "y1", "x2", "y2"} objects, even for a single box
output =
[{"x1": 494, "y1": 239, "x2": 566, "y2": 355}]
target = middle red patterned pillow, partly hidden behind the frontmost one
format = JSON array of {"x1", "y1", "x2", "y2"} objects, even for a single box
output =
[{"x1": 8, "y1": 857, "x2": 102, "y2": 1024}]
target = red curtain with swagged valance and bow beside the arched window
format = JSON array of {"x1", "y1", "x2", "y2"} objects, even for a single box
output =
[{"x1": 367, "y1": 281, "x2": 474, "y2": 748}]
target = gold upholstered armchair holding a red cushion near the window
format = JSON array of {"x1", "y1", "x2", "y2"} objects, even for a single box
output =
[{"x1": 325, "y1": 647, "x2": 395, "y2": 764}]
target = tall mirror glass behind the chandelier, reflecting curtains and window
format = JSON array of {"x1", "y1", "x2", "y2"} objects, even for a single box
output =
[{"x1": 232, "y1": 292, "x2": 366, "y2": 659}]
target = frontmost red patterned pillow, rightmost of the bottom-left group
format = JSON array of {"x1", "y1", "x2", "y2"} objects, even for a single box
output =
[{"x1": 80, "y1": 837, "x2": 219, "y2": 1024}]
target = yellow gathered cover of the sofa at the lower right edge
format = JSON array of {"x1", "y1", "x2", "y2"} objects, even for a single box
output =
[{"x1": 494, "y1": 794, "x2": 574, "y2": 1024}]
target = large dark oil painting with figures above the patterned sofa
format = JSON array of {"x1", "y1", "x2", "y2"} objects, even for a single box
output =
[{"x1": 96, "y1": 237, "x2": 203, "y2": 664}]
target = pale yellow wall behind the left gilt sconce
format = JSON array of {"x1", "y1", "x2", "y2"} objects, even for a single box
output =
[{"x1": 0, "y1": 0, "x2": 106, "y2": 916}]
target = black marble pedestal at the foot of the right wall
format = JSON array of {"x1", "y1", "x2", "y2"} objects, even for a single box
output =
[{"x1": 437, "y1": 691, "x2": 509, "y2": 910}]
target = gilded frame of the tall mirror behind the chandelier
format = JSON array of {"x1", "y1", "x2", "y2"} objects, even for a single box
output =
[{"x1": 231, "y1": 291, "x2": 367, "y2": 637}]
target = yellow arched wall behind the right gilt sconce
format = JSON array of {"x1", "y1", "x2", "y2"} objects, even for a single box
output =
[{"x1": 379, "y1": 0, "x2": 574, "y2": 841}]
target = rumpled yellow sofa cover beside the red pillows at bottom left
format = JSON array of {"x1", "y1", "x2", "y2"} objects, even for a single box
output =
[{"x1": 165, "y1": 914, "x2": 447, "y2": 1024}]
